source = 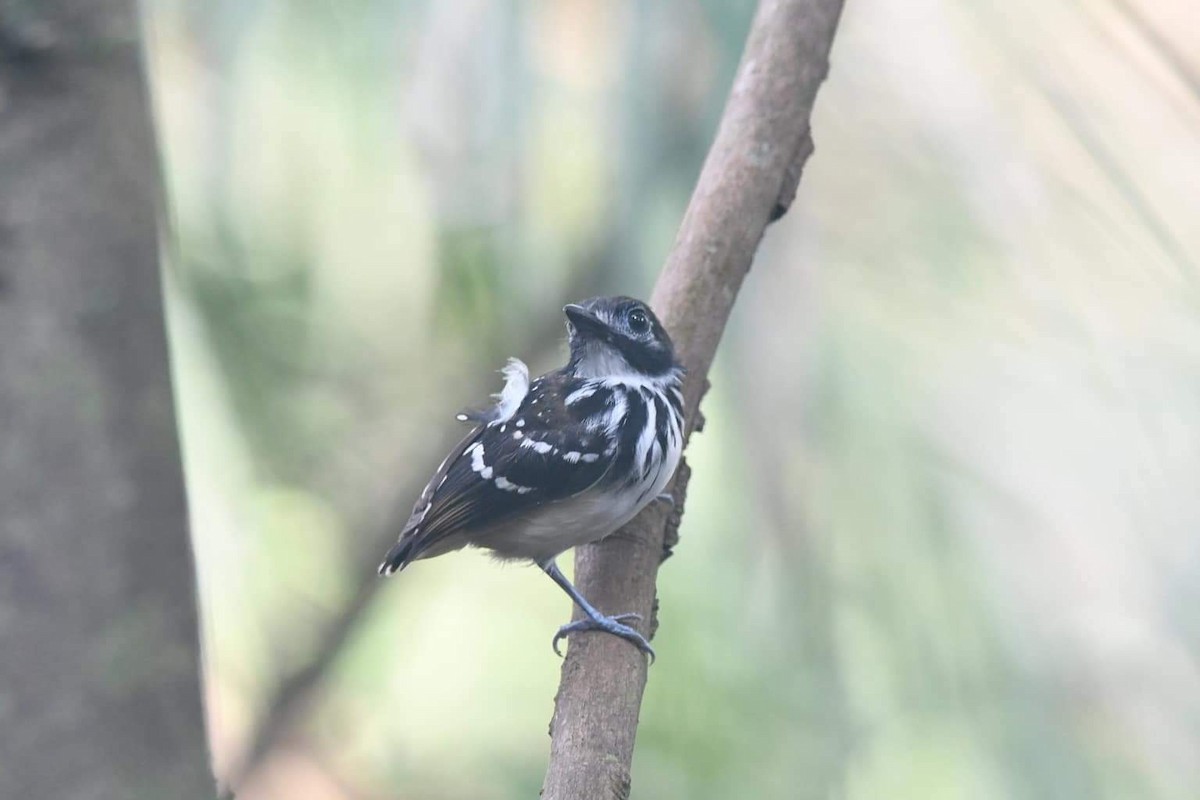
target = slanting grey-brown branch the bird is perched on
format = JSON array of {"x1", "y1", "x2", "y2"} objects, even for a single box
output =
[{"x1": 542, "y1": 0, "x2": 842, "y2": 800}]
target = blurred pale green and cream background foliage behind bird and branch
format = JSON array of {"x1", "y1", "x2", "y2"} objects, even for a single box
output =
[{"x1": 145, "y1": 0, "x2": 1200, "y2": 800}]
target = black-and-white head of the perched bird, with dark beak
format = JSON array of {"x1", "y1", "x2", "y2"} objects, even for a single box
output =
[{"x1": 563, "y1": 297, "x2": 679, "y2": 379}]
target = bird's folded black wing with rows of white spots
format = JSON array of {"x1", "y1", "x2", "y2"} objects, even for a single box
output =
[{"x1": 379, "y1": 375, "x2": 613, "y2": 575}]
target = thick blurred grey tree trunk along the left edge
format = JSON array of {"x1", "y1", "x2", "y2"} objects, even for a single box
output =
[{"x1": 0, "y1": 0, "x2": 215, "y2": 800}]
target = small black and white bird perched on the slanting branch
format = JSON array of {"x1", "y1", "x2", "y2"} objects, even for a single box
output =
[{"x1": 379, "y1": 297, "x2": 683, "y2": 658}]
